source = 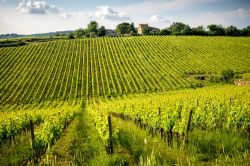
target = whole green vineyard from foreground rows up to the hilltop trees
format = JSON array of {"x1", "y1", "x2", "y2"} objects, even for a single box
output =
[{"x1": 0, "y1": 36, "x2": 250, "y2": 165}]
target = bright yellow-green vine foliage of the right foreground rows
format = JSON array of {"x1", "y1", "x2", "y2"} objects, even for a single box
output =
[{"x1": 92, "y1": 86, "x2": 250, "y2": 134}]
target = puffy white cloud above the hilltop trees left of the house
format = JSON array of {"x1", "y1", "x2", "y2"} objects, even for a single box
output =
[{"x1": 87, "y1": 6, "x2": 130, "y2": 20}]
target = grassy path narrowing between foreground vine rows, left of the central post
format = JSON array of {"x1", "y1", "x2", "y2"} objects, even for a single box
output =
[{"x1": 44, "y1": 102, "x2": 134, "y2": 166}]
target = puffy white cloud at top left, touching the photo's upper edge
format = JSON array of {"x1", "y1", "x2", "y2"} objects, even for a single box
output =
[{"x1": 17, "y1": 0, "x2": 60, "y2": 14}]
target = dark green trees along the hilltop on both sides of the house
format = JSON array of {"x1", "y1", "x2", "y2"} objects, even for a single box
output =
[{"x1": 68, "y1": 21, "x2": 250, "y2": 39}]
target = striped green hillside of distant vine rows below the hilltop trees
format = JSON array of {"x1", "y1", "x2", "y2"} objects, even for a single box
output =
[{"x1": 0, "y1": 36, "x2": 250, "y2": 106}]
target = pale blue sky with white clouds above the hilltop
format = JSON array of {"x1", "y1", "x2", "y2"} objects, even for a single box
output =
[{"x1": 0, "y1": 0, "x2": 250, "y2": 34}]
